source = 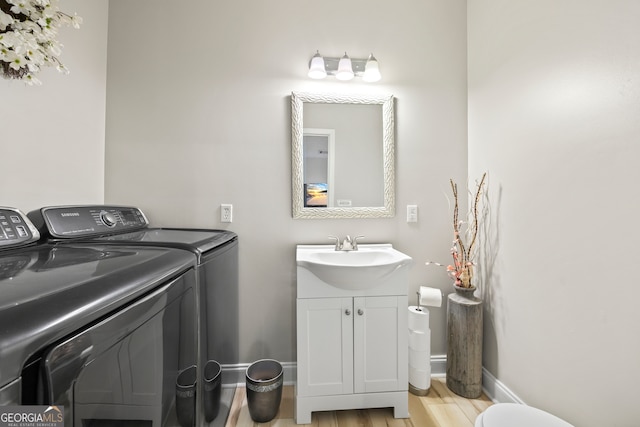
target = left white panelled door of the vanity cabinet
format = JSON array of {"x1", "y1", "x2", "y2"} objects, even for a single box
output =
[{"x1": 297, "y1": 298, "x2": 353, "y2": 396}]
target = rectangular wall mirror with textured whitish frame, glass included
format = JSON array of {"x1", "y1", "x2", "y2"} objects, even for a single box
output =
[{"x1": 291, "y1": 92, "x2": 395, "y2": 219}]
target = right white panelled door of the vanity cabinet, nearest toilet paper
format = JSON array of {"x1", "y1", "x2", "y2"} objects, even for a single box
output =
[{"x1": 353, "y1": 296, "x2": 408, "y2": 393}]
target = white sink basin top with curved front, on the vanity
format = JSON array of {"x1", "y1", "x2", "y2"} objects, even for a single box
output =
[{"x1": 296, "y1": 244, "x2": 412, "y2": 290}]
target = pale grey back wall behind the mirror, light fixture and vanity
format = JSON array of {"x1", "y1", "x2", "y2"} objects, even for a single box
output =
[{"x1": 105, "y1": 0, "x2": 467, "y2": 362}]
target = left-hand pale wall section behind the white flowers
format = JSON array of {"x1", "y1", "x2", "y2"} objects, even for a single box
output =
[{"x1": 0, "y1": 0, "x2": 108, "y2": 212}]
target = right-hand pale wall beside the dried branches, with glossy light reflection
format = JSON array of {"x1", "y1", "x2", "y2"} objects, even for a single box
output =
[{"x1": 468, "y1": 0, "x2": 640, "y2": 427}]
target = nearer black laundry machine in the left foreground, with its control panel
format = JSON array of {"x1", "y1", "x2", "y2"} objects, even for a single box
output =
[{"x1": 0, "y1": 208, "x2": 198, "y2": 427}]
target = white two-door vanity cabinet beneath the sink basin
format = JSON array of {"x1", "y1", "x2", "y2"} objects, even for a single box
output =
[{"x1": 295, "y1": 244, "x2": 409, "y2": 424}]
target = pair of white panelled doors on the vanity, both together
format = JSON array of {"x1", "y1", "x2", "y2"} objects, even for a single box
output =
[{"x1": 297, "y1": 296, "x2": 407, "y2": 396}]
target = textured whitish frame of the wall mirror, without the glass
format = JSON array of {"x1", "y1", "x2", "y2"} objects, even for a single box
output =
[{"x1": 291, "y1": 92, "x2": 395, "y2": 219}]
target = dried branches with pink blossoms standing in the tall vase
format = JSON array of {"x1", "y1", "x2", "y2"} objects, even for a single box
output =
[{"x1": 426, "y1": 172, "x2": 487, "y2": 288}]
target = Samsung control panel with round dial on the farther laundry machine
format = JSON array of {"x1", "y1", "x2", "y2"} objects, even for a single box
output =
[{"x1": 29, "y1": 205, "x2": 149, "y2": 239}]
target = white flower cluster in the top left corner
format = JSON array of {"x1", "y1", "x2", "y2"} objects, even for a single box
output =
[{"x1": 0, "y1": 0, "x2": 82, "y2": 85}]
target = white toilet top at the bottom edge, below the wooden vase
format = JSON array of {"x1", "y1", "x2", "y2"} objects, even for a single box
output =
[{"x1": 475, "y1": 403, "x2": 573, "y2": 427}]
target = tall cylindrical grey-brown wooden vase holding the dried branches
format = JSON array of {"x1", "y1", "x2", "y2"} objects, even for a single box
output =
[{"x1": 447, "y1": 287, "x2": 482, "y2": 399}]
